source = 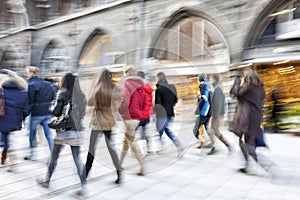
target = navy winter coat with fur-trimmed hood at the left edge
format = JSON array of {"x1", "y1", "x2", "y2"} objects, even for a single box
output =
[{"x1": 0, "y1": 77, "x2": 29, "y2": 132}]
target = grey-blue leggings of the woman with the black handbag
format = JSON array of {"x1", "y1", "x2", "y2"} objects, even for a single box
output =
[{"x1": 45, "y1": 144, "x2": 86, "y2": 186}]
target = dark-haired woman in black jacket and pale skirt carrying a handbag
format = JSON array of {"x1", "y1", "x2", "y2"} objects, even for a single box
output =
[{"x1": 36, "y1": 73, "x2": 86, "y2": 195}]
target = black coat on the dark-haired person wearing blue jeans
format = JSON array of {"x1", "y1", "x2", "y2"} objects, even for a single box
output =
[{"x1": 155, "y1": 82, "x2": 178, "y2": 118}]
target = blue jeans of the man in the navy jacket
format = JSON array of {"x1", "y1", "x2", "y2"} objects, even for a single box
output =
[{"x1": 29, "y1": 115, "x2": 53, "y2": 151}]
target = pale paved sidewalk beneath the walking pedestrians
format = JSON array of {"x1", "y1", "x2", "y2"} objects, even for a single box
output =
[{"x1": 0, "y1": 116, "x2": 300, "y2": 200}]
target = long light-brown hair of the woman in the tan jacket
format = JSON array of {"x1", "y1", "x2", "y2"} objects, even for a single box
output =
[{"x1": 94, "y1": 69, "x2": 115, "y2": 110}]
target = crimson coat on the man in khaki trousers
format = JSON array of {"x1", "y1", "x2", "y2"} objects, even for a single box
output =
[{"x1": 118, "y1": 76, "x2": 146, "y2": 120}]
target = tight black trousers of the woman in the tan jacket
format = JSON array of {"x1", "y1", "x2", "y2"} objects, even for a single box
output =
[{"x1": 85, "y1": 130, "x2": 121, "y2": 176}]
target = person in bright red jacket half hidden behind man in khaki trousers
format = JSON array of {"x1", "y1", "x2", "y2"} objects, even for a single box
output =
[{"x1": 137, "y1": 71, "x2": 153, "y2": 153}]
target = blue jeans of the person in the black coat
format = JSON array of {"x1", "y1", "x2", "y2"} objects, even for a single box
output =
[{"x1": 156, "y1": 117, "x2": 181, "y2": 148}]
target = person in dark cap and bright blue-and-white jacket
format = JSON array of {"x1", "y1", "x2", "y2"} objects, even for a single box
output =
[{"x1": 193, "y1": 73, "x2": 212, "y2": 148}]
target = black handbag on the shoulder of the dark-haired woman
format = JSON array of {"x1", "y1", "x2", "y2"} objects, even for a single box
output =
[{"x1": 48, "y1": 101, "x2": 75, "y2": 132}]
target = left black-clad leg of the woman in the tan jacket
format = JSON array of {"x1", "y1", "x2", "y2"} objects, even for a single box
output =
[{"x1": 85, "y1": 130, "x2": 100, "y2": 177}]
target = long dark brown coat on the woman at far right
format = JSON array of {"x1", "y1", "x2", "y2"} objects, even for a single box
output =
[{"x1": 230, "y1": 84, "x2": 265, "y2": 137}]
